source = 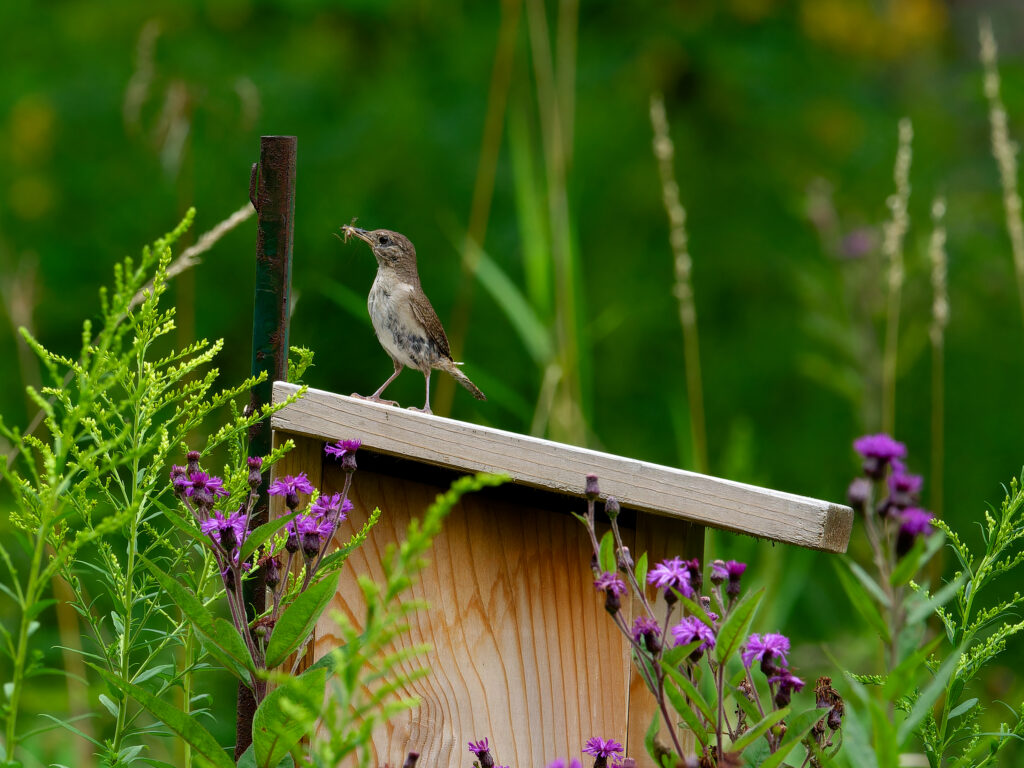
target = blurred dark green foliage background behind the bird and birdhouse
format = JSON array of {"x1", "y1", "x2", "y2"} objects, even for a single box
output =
[{"x1": 0, "y1": 0, "x2": 1024, "y2": 765}]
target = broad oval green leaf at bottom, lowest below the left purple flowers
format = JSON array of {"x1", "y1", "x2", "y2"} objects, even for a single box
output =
[{"x1": 253, "y1": 668, "x2": 327, "y2": 768}]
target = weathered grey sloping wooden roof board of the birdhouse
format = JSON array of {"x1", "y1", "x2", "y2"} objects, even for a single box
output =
[{"x1": 271, "y1": 382, "x2": 853, "y2": 552}]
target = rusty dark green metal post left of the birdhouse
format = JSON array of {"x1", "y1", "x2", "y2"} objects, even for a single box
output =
[{"x1": 241, "y1": 136, "x2": 297, "y2": 760}]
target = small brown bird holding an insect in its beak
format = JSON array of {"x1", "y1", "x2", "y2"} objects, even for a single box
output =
[{"x1": 341, "y1": 224, "x2": 487, "y2": 414}]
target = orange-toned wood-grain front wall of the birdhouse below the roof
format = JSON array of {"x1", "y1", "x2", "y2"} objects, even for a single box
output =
[{"x1": 314, "y1": 466, "x2": 642, "y2": 768}]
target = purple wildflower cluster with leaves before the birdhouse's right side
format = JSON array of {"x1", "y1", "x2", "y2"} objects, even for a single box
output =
[{"x1": 577, "y1": 475, "x2": 845, "y2": 768}]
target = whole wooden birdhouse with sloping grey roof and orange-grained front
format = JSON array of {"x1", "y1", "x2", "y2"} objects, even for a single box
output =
[{"x1": 271, "y1": 382, "x2": 852, "y2": 768}]
